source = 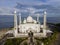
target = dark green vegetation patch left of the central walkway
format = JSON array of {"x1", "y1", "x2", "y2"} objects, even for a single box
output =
[{"x1": 5, "y1": 38, "x2": 27, "y2": 45}]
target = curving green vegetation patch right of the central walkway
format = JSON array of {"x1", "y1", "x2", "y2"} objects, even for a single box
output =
[{"x1": 35, "y1": 32, "x2": 58, "y2": 45}]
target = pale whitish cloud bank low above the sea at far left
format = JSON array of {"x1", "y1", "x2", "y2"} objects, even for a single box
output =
[{"x1": 0, "y1": 7, "x2": 19, "y2": 15}]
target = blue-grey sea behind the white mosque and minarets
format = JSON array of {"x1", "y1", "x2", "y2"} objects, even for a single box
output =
[{"x1": 0, "y1": 15, "x2": 60, "y2": 28}]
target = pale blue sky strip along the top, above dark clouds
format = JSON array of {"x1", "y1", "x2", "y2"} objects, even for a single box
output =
[{"x1": 0, "y1": 0, "x2": 60, "y2": 7}]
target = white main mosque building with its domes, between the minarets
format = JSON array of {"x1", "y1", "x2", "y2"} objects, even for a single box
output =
[{"x1": 19, "y1": 16, "x2": 40, "y2": 33}]
